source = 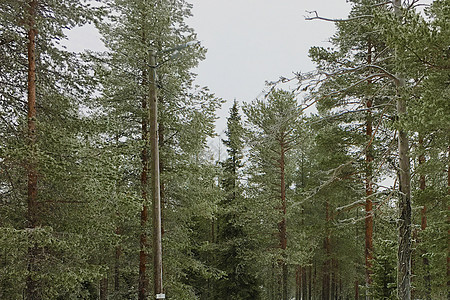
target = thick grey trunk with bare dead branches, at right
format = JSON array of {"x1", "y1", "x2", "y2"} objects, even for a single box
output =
[{"x1": 393, "y1": 0, "x2": 411, "y2": 300}]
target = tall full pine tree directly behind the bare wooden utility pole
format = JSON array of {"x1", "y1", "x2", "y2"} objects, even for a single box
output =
[{"x1": 93, "y1": 0, "x2": 221, "y2": 299}]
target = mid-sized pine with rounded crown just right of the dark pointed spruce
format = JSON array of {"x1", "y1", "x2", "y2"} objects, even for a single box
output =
[{"x1": 244, "y1": 90, "x2": 301, "y2": 299}]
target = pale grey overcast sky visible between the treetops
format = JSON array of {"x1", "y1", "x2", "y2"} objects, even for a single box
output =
[{"x1": 67, "y1": 0, "x2": 350, "y2": 133}]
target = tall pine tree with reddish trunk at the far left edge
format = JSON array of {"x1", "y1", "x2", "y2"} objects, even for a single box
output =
[{"x1": 0, "y1": 0, "x2": 105, "y2": 299}]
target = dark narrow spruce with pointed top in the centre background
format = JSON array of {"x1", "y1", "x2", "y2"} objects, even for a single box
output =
[{"x1": 214, "y1": 100, "x2": 259, "y2": 299}]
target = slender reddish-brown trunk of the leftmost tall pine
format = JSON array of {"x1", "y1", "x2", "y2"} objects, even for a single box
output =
[{"x1": 25, "y1": 0, "x2": 41, "y2": 300}]
